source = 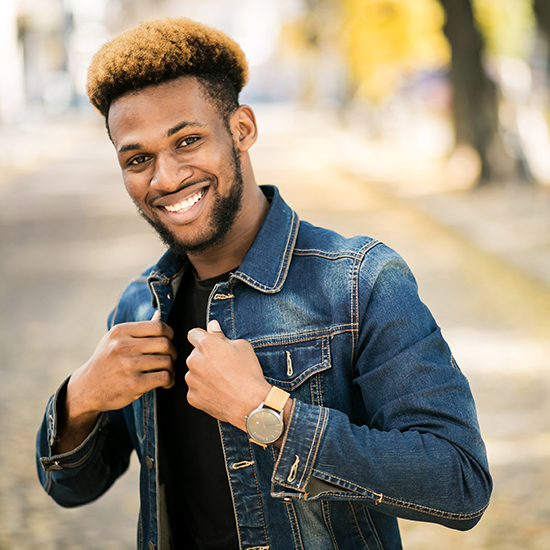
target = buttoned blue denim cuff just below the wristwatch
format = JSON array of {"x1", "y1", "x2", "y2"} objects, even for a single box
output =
[{"x1": 271, "y1": 399, "x2": 329, "y2": 498}]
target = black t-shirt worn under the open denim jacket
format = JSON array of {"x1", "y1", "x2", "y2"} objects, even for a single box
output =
[{"x1": 158, "y1": 267, "x2": 239, "y2": 550}]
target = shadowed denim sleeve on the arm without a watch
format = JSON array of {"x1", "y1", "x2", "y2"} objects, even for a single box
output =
[{"x1": 36, "y1": 378, "x2": 133, "y2": 507}]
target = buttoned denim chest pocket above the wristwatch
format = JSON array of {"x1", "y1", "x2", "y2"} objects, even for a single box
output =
[{"x1": 254, "y1": 337, "x2": 331, "y2": 405}]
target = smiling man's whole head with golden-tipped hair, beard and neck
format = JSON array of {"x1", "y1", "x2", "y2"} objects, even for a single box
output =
[{"x1": 88, "y1": 18, "x2": 266, "y2": 274}]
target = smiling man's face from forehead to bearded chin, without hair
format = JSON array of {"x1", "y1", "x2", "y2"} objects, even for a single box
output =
[{"x1": 109, "y1": 78, "x2": 243, "y2": 255}]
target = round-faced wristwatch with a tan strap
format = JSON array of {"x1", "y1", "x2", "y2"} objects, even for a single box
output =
[{"x1": 246, "y1": 386, "x2": 290, "y2": 447}]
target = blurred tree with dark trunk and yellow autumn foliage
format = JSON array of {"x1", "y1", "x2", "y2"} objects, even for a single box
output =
[{"x1": 288, "y1": 0, "x2": 536, "y2": 184}]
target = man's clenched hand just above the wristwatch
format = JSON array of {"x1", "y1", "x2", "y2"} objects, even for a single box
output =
[{"x1": 185, "y1": 321, "x2": 271, "y2": 431}]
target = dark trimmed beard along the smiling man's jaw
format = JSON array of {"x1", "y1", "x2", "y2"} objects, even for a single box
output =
[{"x1": 136, "y1": 145, "x2": 244, "y2": 258}]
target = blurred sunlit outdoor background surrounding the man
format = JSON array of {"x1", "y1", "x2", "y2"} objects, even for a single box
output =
[{"x1": 0, "y1": 0, "x2": 550, "y2": 550}]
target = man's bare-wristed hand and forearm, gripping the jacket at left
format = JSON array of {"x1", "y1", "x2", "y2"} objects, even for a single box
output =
[{"x1": 53, "y1": 320, "x2": 177, "y2": 454}]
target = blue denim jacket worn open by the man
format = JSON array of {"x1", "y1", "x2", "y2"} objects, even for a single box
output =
[{"x1": 37, "y1": 187, "x2": 492, "y2": 550}]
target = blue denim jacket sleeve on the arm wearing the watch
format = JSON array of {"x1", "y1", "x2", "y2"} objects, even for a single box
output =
[{"x1": 272, "y1": 247, "x2": 492, "y2": 530}]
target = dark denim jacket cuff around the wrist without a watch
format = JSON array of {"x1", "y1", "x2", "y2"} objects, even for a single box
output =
[{"x1": 40, "y1": 376, "x2": 109, "y2": 472}]
